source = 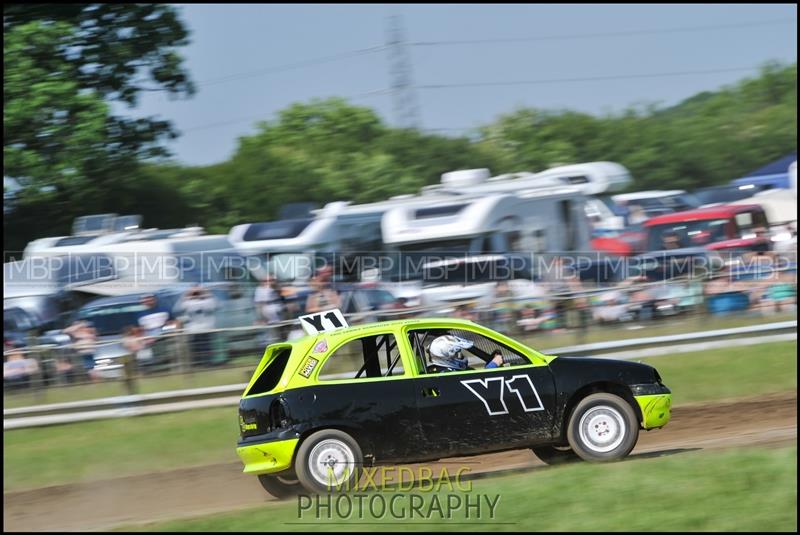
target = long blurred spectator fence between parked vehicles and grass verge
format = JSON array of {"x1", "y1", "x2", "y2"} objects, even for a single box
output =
[{"x1": 3, "y1": 270, "x2": 797, "y2": 397}]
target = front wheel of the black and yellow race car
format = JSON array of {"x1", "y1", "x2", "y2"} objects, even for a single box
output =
[{"x1": 567, "y1": 393, "x2": 639, "y2": 462}]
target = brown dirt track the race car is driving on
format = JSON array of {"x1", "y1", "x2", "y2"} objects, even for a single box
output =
[{"x1": 3, "y1": 392, "x2": 797, "y2": 531}]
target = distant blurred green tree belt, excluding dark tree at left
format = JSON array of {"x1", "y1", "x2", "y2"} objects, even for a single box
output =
[{"x1": 170, "y1": 64, "x2": 797, "y2": 231}]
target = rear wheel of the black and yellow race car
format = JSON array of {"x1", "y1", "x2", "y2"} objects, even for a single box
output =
[{"x1": 295, "y1": 429, "x2": 364, "y2": 493}]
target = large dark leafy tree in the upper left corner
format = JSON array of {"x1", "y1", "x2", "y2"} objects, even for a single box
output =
[{"x1": 3, "y1": 4, "x2": 193, "y2": 254}]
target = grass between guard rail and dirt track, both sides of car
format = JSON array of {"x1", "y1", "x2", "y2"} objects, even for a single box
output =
[{"x1": 3, "y1": 342, "x2": 797, "y2": 491}]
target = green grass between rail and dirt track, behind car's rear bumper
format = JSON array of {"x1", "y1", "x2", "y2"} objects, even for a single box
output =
[{"x1": 3, "y1": 407, "x2": 239, "y2": 491}]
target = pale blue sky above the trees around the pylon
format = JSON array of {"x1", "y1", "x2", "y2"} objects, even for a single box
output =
[{"x1": 125, "y1": 4, "x2": 797, "y2": 165}]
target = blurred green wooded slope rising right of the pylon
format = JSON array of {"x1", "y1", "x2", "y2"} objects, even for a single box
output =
[{"x1": 480, "y1": 64, "x2": 797, "y2": 190}]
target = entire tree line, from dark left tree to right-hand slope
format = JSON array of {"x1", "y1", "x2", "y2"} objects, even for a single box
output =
[{"x1": 3, "y1": 4, "x2": 797, "y2": 255}]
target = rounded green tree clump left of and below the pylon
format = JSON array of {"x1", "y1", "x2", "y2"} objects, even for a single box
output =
[{"x1": 174, "y1": 98, "x2": 491, "y2": 231}]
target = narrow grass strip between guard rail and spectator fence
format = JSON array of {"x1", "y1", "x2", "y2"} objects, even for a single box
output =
[{"x1": 3, "y1": 313, "x2": 797, "y2": 408}]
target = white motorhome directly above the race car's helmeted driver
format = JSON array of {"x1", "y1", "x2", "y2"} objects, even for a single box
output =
[{"x1": 381, "y1": 187, "x2": 591, "y2": 304}]
